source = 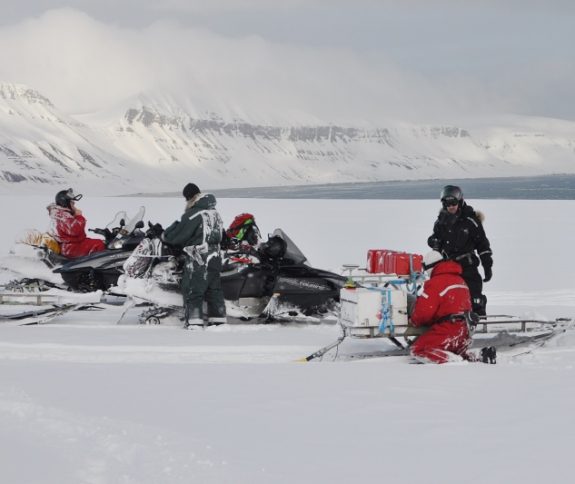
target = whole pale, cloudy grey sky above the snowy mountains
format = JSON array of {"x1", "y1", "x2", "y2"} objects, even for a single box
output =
[{"x1": 0, "y1": 0, "x2": 575, "y2": 122}]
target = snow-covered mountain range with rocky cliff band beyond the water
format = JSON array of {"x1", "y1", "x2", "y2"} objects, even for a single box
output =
[{"x1": 0, "y1": 84, "x2": 575, "y2": 192}]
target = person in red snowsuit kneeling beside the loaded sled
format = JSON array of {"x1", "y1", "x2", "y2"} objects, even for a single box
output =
[{"x1": 411, "y1": 251, "x2": 474, "y2": 363}]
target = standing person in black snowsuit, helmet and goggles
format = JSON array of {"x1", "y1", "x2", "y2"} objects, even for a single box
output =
[{"x1": 427, "y1": 185, "x2": 493, "y2": 316}]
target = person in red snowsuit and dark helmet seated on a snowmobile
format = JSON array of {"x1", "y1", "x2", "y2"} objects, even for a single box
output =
[{"x1": 46, "y1": 188, "x2": 106, "y2": 258}]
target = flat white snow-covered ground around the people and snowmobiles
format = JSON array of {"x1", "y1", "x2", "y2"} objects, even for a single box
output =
[{"x1": 0, "y1": 194, "x2": 575, "y2": 484}]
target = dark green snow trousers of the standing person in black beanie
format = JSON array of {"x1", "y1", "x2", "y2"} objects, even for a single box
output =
[{"x1": 181, "y1": 253, "x2": 230, "y2": 326}]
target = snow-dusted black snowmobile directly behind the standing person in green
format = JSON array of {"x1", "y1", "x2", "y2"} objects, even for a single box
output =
[{"x1": 114, "y1": 224, "x2": 346, "y2": 324}]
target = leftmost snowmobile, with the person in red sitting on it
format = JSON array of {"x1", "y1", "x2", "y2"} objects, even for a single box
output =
[{"x1": 1, "y1": 207, "x2": 145, "y2": 292}]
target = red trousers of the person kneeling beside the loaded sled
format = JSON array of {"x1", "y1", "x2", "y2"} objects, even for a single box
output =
[{"x1": 411, "y1": 321, "x2": 471, "y2": 363}]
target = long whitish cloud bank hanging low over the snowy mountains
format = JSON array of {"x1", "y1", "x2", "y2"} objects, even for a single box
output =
[{"x1": 0, "y1": 9, "x2": 460, "y2": 120}]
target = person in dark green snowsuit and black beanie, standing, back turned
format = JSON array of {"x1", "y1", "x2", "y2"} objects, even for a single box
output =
[{"x1": 162, "y1": 183, "x2": 226, "y2": 328}]
